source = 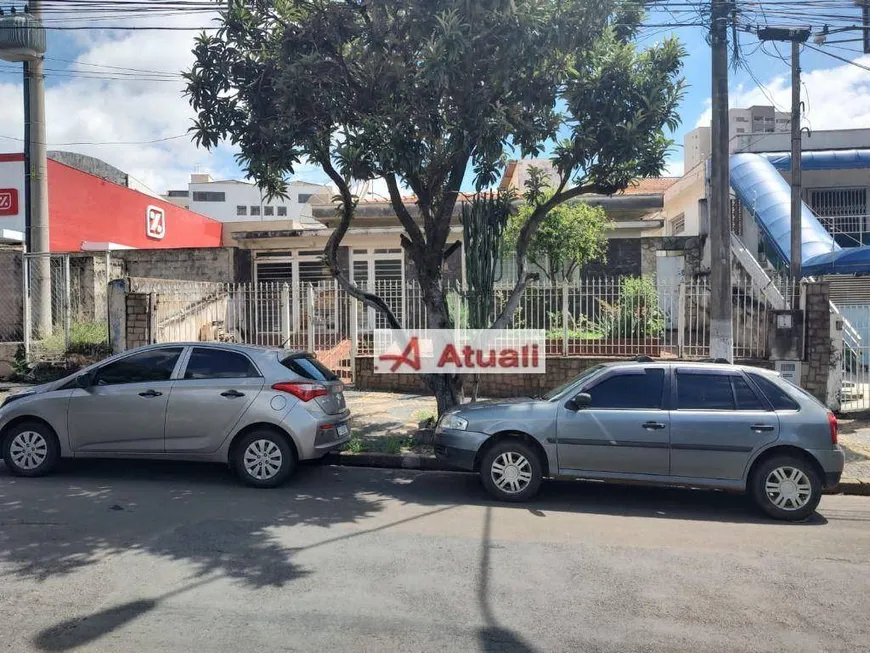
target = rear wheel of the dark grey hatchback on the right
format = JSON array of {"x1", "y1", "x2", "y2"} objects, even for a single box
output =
[{"x1": 750, "y1": 456, "x2": 822, "y2": 521}]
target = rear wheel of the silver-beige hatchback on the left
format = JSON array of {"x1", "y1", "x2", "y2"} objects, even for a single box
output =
[{"x1": 231, "y1": 430, "x2": 297, "y2": 488}]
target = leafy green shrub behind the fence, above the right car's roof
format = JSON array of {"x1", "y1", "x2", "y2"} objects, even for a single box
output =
[{"x1": 598, "y1": 277, "x2": 665, "y2": 338}]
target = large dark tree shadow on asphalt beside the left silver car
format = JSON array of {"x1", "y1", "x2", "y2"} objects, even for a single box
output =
[{"x1": 0, "y1": 461, "x2": 382, "y2": 588}]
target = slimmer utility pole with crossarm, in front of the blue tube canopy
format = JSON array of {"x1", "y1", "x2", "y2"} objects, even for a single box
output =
[{"x1": 758, "y1": 27, "x2": 810, "y2": 310}]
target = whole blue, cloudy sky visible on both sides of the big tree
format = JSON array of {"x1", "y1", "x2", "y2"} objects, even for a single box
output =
[{"x1": 0, "y1": 0, "x2": 870, "y2": 192}]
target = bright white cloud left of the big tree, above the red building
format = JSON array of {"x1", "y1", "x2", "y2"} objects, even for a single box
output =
[{"x1": 0, "y1": 0, "x2": 237, "y2": 192}]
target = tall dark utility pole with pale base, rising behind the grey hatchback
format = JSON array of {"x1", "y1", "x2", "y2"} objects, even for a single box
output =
[{"x1": 707, "y1": 0, "x2": 734, "y2": 362}]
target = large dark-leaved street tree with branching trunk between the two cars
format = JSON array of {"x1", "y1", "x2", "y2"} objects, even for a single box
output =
[{"x1": 185, "y1": 0, "x2": 683, "y2": 411}]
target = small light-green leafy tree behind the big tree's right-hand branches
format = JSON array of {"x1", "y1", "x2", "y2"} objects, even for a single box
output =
[{"x1": 505, "y1": 197, "x2": 610, "y2": 283}]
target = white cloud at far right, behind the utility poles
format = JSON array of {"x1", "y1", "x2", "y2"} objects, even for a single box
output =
[{"x1": 696, "y1": 55, "x2": 870, "y2": 131}]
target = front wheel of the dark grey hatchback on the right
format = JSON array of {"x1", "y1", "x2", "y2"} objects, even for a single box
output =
[{"x1": 480, "y1": 439, "x2": 543, "y2": 501}]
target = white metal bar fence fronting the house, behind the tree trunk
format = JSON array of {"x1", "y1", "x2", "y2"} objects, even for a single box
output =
[{"x1": 140, "y1": 277, "x2": 787, "y2": 377}]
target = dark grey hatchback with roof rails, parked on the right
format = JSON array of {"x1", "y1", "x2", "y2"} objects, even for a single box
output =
[{"x1": 435, "y1": 362, "x2": 844, "y2": 520}]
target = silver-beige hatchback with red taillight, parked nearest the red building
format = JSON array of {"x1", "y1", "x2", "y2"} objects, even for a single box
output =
[{"x1": 0, "y1": 342, "x2": 350, "y2": 487}]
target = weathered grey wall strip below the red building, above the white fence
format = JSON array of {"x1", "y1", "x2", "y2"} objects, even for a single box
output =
[{"x1": 112, "y1": 247, "x2": 238, "y2": 282}]
